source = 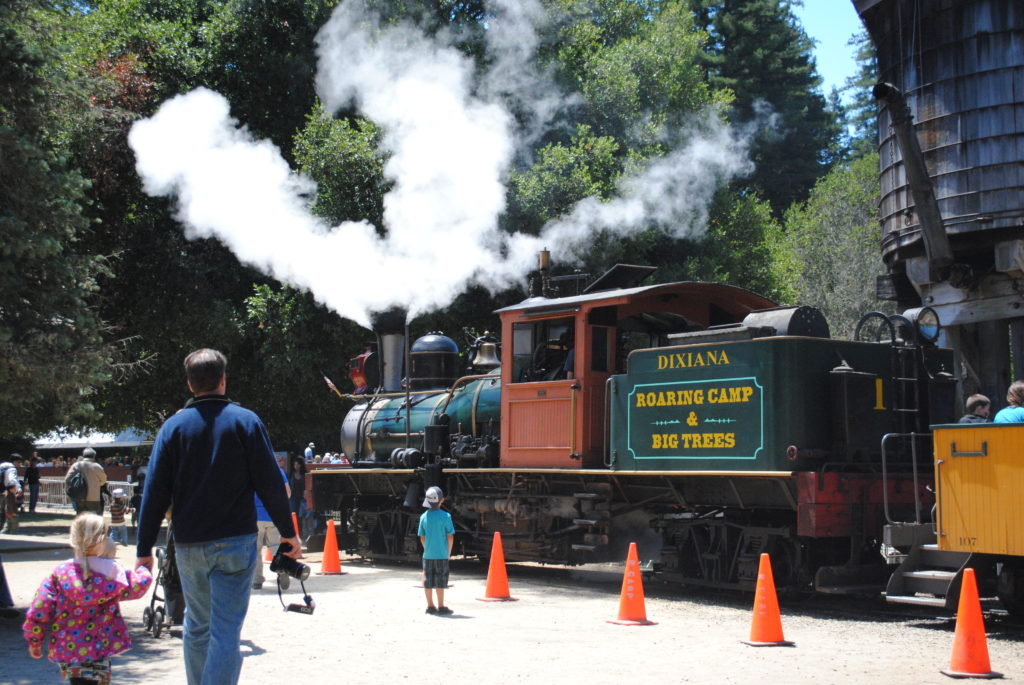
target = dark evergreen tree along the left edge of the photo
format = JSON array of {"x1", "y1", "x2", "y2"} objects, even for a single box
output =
[{"x1": 0, "y1": 0, "x2": 112, "y2": 437}]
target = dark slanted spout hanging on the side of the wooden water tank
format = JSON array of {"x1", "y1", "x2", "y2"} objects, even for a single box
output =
[{"x1": 871, "y1": 83, "x2": 953, "y2": 283}]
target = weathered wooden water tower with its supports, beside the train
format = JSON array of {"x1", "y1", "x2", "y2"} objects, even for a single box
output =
[{"x1": 853, "y1": 0, "x2": 1024, "y2": 398}]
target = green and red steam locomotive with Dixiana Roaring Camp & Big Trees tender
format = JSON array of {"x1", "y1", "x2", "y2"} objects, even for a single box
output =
[{"x1": 310, "y1": 259, "x2": 1013, "y2": 603}]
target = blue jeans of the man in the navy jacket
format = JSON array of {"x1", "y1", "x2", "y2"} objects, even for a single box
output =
[{"x1": 175, "y1": 533, "x2": 259, "y2": 685}]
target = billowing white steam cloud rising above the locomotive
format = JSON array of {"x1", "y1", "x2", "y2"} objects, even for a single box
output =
[{"x1": 129, "y1": 0, "x2": 749, "y2": 325}]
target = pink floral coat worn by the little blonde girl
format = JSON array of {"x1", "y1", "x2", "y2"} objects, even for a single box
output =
[{"x1": 22, "y1": 557, "x2": 153, "y2": 663}]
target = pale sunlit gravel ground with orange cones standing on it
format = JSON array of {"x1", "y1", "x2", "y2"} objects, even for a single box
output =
[{"x1": 0, "y1": 516, "x2": 1024, "y2": 685}]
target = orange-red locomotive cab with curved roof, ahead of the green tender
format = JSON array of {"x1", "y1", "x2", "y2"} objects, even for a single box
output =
[{"x1": 498, "y1": 274, "x2": 773, "y2": 469}]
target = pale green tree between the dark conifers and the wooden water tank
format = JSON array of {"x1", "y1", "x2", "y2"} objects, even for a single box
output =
[{"x1": 770, "y1": 155, "x2": 882, "y2": 337}]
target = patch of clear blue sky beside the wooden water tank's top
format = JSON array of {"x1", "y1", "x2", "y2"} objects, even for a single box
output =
[{"x1": 794, "y1": 0, "x2": 863, "y2": 96}]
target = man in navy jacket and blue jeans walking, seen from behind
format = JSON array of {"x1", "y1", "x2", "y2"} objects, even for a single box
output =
[{"x1": 137, "y1": 349, "x2": 302, "y2": 685}]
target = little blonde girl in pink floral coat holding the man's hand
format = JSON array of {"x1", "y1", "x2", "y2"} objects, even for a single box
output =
[{"x1": 22, "y1": 513, "x2": 153, "y2": 683}]
